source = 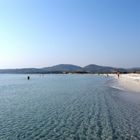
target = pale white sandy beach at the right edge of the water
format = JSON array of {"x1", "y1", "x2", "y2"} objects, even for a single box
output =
[{"x1": 112, "y1": 73, "x2": 140, "y2": 92}]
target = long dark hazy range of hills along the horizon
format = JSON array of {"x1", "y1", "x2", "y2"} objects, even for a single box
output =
[{"x1": 0, "y1": 64, "x2": 140, "y2": 74}]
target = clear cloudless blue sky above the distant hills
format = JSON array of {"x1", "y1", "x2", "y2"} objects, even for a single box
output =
[{"x1": 0, "y1": 0, "x2": 140, "y2": 68}]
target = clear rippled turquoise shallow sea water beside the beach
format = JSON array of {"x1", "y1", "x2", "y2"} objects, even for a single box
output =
[{"x1": 0, "y1": 75, "x2": 140, "y2": 140}]
